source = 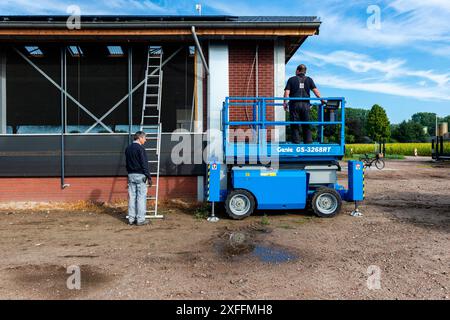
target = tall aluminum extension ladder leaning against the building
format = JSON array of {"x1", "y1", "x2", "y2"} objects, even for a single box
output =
[{"x1": 141, "y1": 46, "x2": 164, "y2": 219}]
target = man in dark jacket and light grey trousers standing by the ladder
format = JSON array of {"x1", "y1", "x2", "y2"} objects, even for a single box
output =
[{"x1": 125, "y1": 131, "x2": 152, "y2": 226}]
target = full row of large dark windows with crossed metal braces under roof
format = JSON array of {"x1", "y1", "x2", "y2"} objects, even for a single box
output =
[{"x1": 6, "y1": 42, "x2": 195, "y2": 134}]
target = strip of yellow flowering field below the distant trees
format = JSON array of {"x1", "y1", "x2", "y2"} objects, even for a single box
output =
[{"x1": 346, "y1": 142, "x2": 450, "y2": 157}]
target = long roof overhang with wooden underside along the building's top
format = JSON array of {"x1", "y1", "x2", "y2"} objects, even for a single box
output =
[{"x1": 0, "y1": 16, "x2": 321, "y2": 59}]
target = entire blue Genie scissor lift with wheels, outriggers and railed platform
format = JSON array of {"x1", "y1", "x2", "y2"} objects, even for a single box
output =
[{"x1": 207, "y1": 97, "x2": 364, "y2": 219}]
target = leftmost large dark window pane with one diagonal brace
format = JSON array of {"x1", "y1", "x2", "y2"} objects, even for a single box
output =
[{"x1": 6, "y1": 45, "x2": 61, "y2": 134}]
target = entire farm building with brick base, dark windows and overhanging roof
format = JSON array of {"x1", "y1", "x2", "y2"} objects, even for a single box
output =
[{"x1": 0, "y1": 16, "x2": 320, "y2": 202}]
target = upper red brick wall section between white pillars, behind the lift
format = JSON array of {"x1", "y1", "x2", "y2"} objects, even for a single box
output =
[{"x1": 229, "y1": 41, "x2": 274, "y2": 141}]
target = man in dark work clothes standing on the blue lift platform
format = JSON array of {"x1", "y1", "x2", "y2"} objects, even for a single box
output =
[{"x1": 284, "y1": 64, "x2": 324, "y2": 144}]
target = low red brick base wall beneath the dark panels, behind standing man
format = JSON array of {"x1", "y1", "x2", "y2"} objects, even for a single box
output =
[{"x1": 0, "y1": 177, "x2": 197, "y2": 202}]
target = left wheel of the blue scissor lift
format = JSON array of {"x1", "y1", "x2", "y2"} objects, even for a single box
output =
[{"x1": 225, "y1": 190, "x2": 255, "y2": 220}]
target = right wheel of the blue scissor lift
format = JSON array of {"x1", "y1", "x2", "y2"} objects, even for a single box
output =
[{"x1": 311, "y1": 188, "x2": 342, "y2": 218}]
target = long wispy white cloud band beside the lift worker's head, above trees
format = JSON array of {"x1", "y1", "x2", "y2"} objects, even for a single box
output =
[{"x1": 292, "y1": 51, "x2": 450, "y2": 101}]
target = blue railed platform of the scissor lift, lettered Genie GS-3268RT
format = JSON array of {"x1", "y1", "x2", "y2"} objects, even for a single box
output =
[{"x1": 222, "y1": 97, "x2": 345, "y2": 162}]
